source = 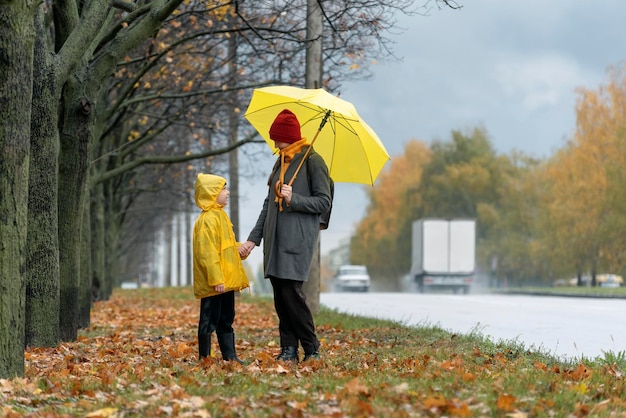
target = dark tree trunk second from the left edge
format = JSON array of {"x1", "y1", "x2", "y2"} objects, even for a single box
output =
[{"x1": 24, "y1": 7, "x2": 59, "y2": 347}]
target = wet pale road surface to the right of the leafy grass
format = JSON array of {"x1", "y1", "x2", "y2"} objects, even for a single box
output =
[{"x1": 320, "y1": 293, "x2": 626, "y2": 359}]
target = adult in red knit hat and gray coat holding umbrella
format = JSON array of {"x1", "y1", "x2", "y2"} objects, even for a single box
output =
[{"x1": 242, "y1": 109, "x2": 331, "y2": 362}]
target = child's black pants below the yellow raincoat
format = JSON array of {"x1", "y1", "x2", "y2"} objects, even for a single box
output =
[{"x1": 198, "y1": 290, "x2": 235, "y2": 335}]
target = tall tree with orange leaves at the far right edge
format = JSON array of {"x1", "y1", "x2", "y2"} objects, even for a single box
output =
[{"x1": 546, "y1": 68, "x2": 626, "y2": 285}]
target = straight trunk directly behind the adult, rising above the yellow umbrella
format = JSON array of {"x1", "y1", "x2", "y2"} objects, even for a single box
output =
[{"x1": 303, "y1": 0, "x2": 323, "y2": 314}]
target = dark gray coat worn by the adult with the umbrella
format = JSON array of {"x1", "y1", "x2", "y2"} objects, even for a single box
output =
[{"x1": 248, "y1": 147, "x2": 331, "y2": 281}]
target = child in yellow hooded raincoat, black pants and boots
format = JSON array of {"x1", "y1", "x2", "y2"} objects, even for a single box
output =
[{"x1": 193, "y1": 174, "x2": 249, "y2": 364}]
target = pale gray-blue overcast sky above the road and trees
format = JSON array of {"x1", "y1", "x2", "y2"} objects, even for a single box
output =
[{"x1": 235, "y1": 0, "x2": 626, "y2": 271}]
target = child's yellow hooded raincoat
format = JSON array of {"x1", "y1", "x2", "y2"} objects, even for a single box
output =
[{"x1": 193, "y1": 174, "x2": 250, "y2": 299}]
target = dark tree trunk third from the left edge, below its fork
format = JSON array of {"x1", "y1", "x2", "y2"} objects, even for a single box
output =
[{"x1": 59, "y1": 80, "x2": 94, "y2": 341}]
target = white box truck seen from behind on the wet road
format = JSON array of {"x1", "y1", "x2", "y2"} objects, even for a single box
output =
[{"x1": 411, "y1": 218, "x2": 476, "y2": 293}]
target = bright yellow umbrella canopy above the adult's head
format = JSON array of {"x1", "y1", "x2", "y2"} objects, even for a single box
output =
[{"x1": 244, "y1": 86, "x2": 389, "y2": 185}]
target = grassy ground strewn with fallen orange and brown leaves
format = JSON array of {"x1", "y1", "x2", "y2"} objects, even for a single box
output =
[{"x1": 0, "y1": 288, "x2": 626, "y2": 417}]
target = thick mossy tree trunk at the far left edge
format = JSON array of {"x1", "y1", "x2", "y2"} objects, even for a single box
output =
[{"x1": 0, "y1": 1, "x2": 35, "y2": 378}]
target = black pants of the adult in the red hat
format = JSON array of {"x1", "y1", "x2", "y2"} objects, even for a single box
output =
[{"x1": 270, "y1": 277, "x2": 320, "y2": 354}]
